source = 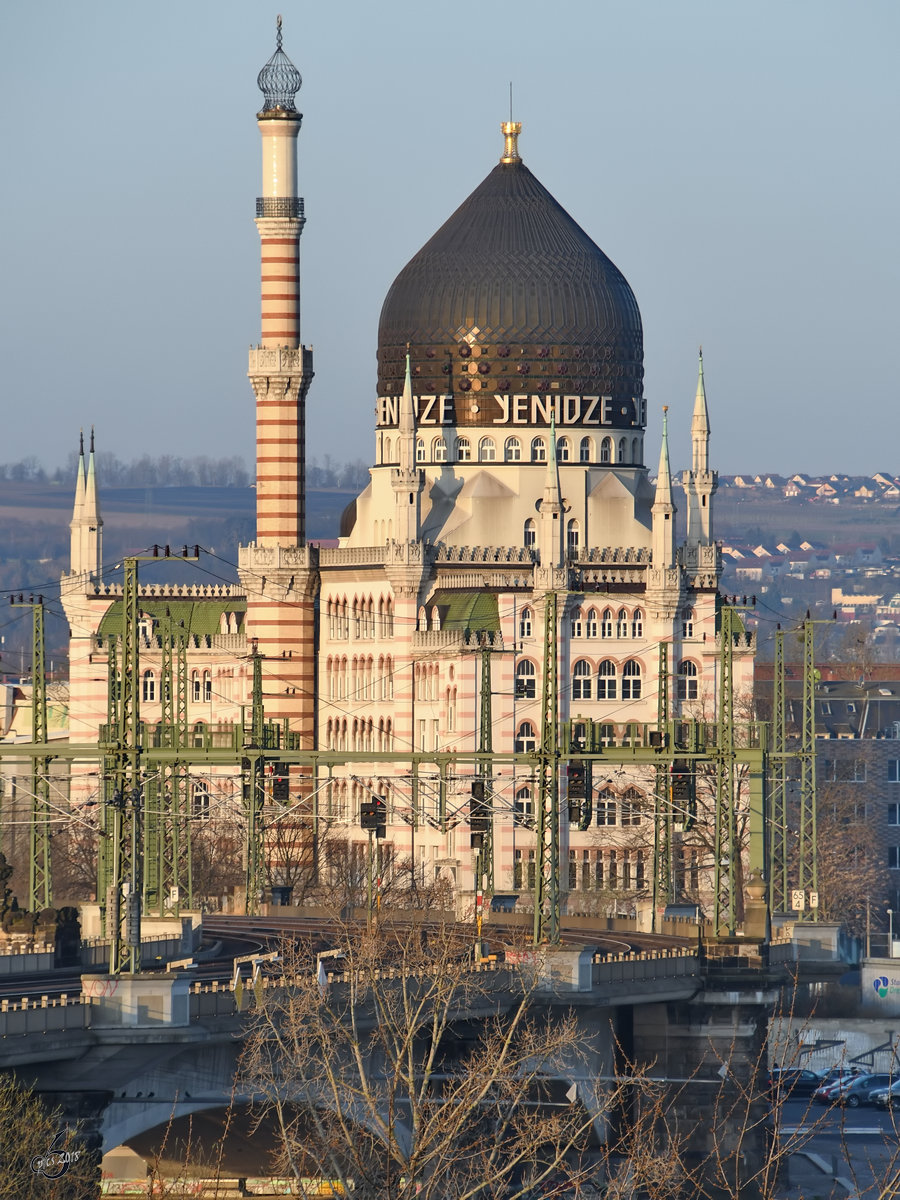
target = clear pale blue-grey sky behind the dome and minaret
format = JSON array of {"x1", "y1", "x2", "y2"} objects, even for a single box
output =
[{"x1": 0, "y1": 0, "x2": 900, "y2": 474}]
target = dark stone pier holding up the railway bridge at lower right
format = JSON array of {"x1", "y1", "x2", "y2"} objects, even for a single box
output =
[{"x1": 632, "y1": 990, "x2": 778, "y2": 1200}]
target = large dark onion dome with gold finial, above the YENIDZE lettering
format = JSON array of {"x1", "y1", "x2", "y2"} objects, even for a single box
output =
[{"x1": 378, "y1": 121, "x2": 643, "y2": 427}]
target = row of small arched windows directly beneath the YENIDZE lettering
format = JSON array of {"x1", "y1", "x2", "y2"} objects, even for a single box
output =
[{"x1": 400, "y1": 434, "x2": 642, "y2": 466}]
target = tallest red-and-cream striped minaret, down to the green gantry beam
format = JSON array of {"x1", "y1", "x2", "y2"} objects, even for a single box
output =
[{"x1": 238, "y1": 17, "x2": 318, "y2": 734}]
